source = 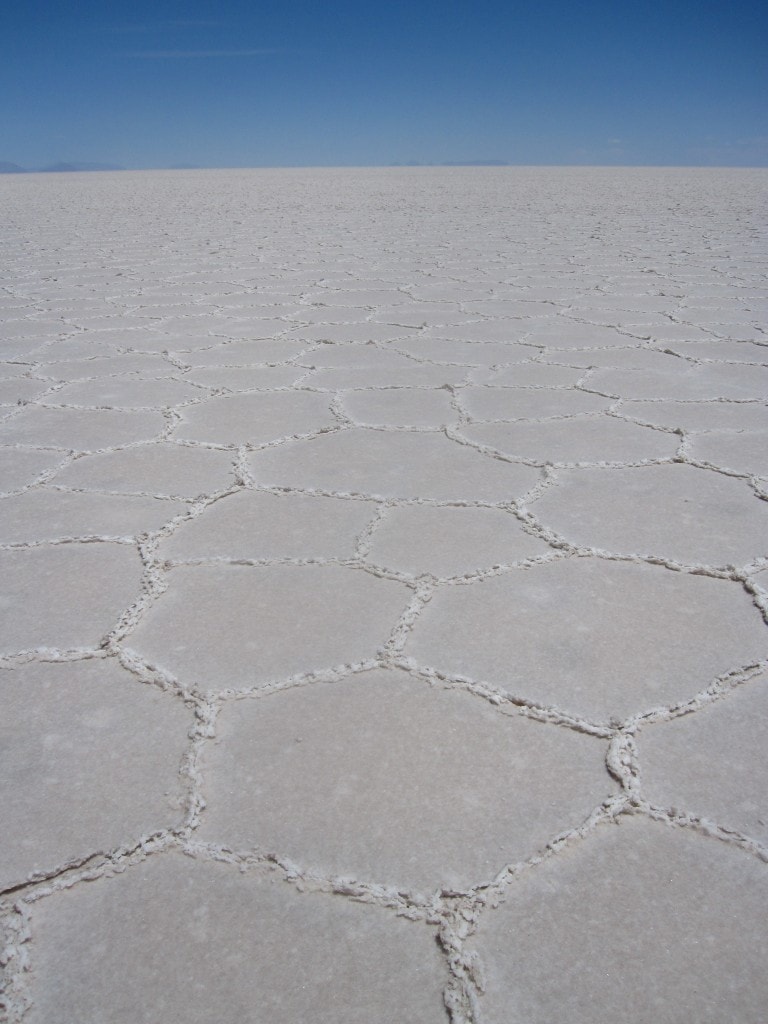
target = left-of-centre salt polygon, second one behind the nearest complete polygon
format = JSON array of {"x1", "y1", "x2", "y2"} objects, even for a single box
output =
[{"x1": 162, "y1": 490, "x2": 373, "y2": 559}]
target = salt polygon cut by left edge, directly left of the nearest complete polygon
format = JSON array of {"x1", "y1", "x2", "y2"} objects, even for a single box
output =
[{"x1": 0, "y1": 658, "x2": 193, "y2": 886}]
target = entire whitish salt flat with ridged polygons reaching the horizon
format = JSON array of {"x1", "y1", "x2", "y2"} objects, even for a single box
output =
[{"x1": 0, "y1": 168, "x2": 768, "y2": 1024}]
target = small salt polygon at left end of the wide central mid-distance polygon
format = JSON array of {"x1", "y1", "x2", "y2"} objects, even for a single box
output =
[{"x1": 55, "y1": 441, "x2": 234, "y2": 498}]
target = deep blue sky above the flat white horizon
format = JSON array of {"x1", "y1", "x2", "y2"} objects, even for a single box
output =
[{"x1": 0, "y1": 0, "x2": 768, "y2": 168}]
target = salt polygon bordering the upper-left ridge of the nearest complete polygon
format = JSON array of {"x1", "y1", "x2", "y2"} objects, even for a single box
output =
[{"x1": 127, "y1": 564, "x2": 411, "y2": 691}]
